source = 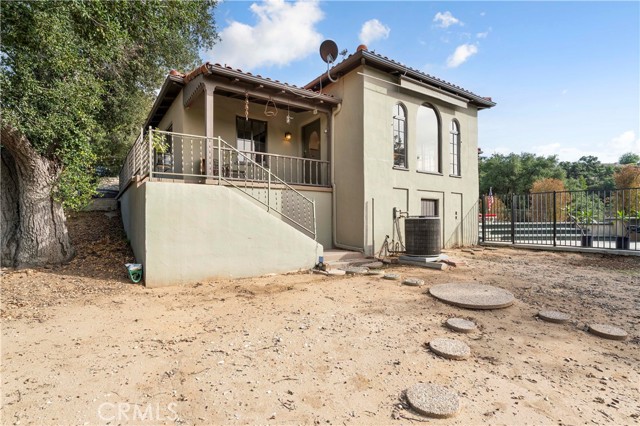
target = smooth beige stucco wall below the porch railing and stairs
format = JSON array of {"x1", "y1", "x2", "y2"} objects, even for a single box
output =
[{"x1": 122, "y1": 182, "x2": 323, "y2": 287}]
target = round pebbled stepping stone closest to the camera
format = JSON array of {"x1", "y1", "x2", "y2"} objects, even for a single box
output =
[{"x1": 405, "y1": 383, "x2": 460, "y2": 419}]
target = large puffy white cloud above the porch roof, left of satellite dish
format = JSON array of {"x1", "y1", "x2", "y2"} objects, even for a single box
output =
[{"x1": 203, "y1": 0, "x2": 324, "y2": 71}]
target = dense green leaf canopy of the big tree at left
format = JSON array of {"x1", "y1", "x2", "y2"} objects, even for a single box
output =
[{"x1": 0, "y1": 0, "x2": 217, "y2": 208}]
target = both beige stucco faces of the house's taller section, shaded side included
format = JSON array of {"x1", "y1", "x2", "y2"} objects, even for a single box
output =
[{"x1": 330, "y1": 67, "x2": 478, "y2": 254}]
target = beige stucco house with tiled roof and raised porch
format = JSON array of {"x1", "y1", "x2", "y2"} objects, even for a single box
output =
[{"x1": 119, "y1": 46, "x2": 495, "y2": 286}]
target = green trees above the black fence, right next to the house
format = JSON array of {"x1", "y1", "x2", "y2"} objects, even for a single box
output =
[{"x1": 479, "y1": 153, "x2": 565, "y2": 194}]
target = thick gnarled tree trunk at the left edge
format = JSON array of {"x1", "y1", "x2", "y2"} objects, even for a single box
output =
[{"x1": 0, "y1": 125, "x2": 74, "y2": 267}]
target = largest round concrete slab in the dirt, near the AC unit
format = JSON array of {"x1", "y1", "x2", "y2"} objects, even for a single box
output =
[{"x1": 429, "y1": 283, "x2": 516, "y2": 309}]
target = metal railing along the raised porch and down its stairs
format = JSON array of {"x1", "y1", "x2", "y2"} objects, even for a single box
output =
[{"x1": 120, "y1": 129, "x2": 318, "y2": 239}]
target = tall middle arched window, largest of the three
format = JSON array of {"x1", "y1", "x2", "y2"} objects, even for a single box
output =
[{"x1": 416, "y1": 105, "x2": 442, "y2": 173}]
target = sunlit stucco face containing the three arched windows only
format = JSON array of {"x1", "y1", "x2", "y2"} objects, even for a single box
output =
[{"x1": 362, "y1": 67, "x2": 478, "y2": 254}]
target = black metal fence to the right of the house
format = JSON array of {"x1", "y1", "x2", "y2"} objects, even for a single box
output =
[{"x1": 478, "y1": 188, "x2": 640, "y2": 251}]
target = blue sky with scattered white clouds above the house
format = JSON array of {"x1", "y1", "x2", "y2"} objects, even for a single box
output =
[{"x1": 201, "y1": 0, "x2": 640, "y2": 162}]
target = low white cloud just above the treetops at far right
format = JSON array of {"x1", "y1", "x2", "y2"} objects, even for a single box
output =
[{"x1": 533, "y1": 130, "x2": 640, "y2": 163}]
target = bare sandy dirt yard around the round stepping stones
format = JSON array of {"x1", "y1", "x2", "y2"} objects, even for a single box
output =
[{"x1": 0, "y1": 213, "x2": 640, "y2": 425}]
